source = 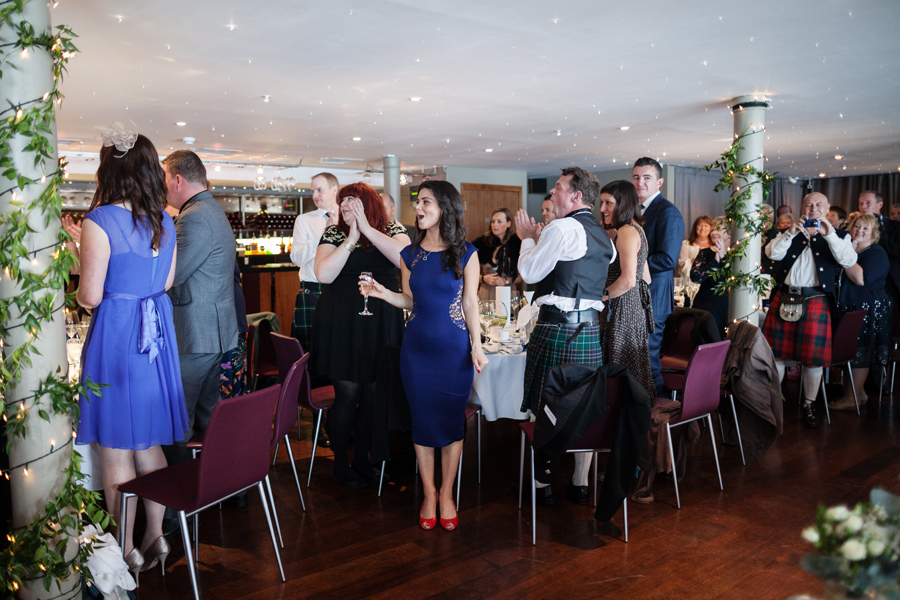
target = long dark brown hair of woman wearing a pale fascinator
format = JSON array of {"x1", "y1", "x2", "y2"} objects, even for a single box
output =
[{"x1": 90, "y1": 135, "x2": 166, "y2": 250}]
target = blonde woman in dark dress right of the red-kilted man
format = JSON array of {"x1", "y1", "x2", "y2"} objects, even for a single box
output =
[{"x1": 828, "y1": 214, "x2": 893, "y2": 410}]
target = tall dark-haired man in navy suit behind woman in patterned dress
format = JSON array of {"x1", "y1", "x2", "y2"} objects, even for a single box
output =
[{"x1": 631, "y1": 156, "x2": 684, "y2": 397}]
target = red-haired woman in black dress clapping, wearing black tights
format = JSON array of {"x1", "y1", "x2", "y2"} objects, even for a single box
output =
[{"x1": 310, "y1": 183, "x2": 409, "y2": 488}]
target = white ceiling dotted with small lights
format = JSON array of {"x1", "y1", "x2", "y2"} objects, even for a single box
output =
[{"x1": 53, "y1": 0, "x2": 900, "y2": 177}]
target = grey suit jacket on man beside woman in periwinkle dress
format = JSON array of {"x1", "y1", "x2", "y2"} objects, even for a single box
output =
[{"x1": 169, "y1": 191, "x2": 238, "y2": 354}]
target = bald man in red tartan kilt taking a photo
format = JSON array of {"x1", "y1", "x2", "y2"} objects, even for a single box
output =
[{"x1": 763, "y1": 192, "x2": 856, "y2": 429}]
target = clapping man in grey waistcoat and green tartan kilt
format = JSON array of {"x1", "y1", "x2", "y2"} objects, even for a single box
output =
[{"x1": 516, "y1": 167, "x2": 616, "y2": 504}]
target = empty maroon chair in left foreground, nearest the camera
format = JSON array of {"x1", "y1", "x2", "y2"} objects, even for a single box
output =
[{"x1": 119, "y1": 385, "x2": 285, "y2": 600}]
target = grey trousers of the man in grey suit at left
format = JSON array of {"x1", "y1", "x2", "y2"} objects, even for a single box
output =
[{"x1": 163, "y1": 352, "x2": 222, "y2": 465}]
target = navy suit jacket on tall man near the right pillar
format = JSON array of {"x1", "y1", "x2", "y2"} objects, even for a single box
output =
[{"x1": 644, "y1": 194, "x2": 684, "y2": 323}]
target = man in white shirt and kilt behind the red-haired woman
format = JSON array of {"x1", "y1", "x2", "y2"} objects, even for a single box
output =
[{"x1": 291, "y1": 173, "x2": 340, "y2": 448}]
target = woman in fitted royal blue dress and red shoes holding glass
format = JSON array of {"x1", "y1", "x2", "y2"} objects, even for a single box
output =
[{"x1": 369, "y1": 181, "x2": 487, "y2": 531}]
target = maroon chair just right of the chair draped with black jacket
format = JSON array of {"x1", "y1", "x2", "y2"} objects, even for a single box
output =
[{"x1": 656, "y1": 340, "x2": 731, "y2": 508}]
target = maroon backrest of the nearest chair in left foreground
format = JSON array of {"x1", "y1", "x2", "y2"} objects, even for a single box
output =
[{"x1": 197, "y1": 384, "x2": 281, "y2": 506}]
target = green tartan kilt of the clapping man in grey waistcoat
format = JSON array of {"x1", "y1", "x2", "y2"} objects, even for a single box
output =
[{"x1": 522, "y1": 322, "x2": 603, "y2": 412}]
